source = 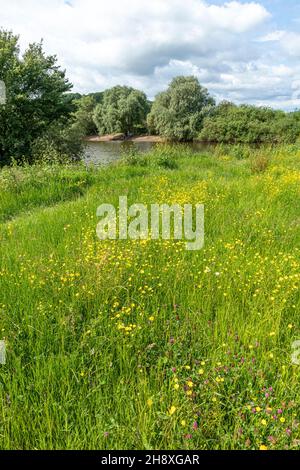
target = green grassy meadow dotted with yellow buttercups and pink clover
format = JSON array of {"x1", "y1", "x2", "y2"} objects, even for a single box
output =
[{"x1": 0, "y1": 145, "x2": 300, "y2": 450}]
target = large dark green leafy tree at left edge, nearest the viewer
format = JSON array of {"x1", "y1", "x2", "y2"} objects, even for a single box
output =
[{"x1": 0, "y1": 30, "x2": 72, "y2": 163}]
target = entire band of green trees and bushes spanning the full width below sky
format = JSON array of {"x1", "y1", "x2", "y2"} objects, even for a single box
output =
[{"x1": 0, "y1": 30, "x2": 300, "y2": 165}]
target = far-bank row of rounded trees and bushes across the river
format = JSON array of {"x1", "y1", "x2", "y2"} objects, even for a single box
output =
[{"x1": 79, "y1": 77, "x2": 300, "y2": 144}]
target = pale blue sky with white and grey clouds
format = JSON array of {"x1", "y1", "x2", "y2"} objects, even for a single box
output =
[{"x1": 0, "y1": 0, "x2": 300, "y2": 110}]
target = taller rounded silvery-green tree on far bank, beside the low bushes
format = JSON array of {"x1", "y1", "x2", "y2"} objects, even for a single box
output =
[{"x1": 148, "y1": 77, "x2": 215, "y2": 141}]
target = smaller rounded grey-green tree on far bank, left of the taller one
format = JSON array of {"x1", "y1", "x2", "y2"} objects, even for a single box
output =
[{"x1": 94, "y1": 86, "x2": 149, "y2": 135}]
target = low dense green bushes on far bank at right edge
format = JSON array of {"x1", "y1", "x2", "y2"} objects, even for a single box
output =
[{"x1": 200, "y1": 102, "x2": 300, "y2": 144}]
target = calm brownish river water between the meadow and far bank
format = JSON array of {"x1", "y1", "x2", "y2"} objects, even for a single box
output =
[{"x1": 84, "y1": 142, "x2": 209, "y2": 165}]
